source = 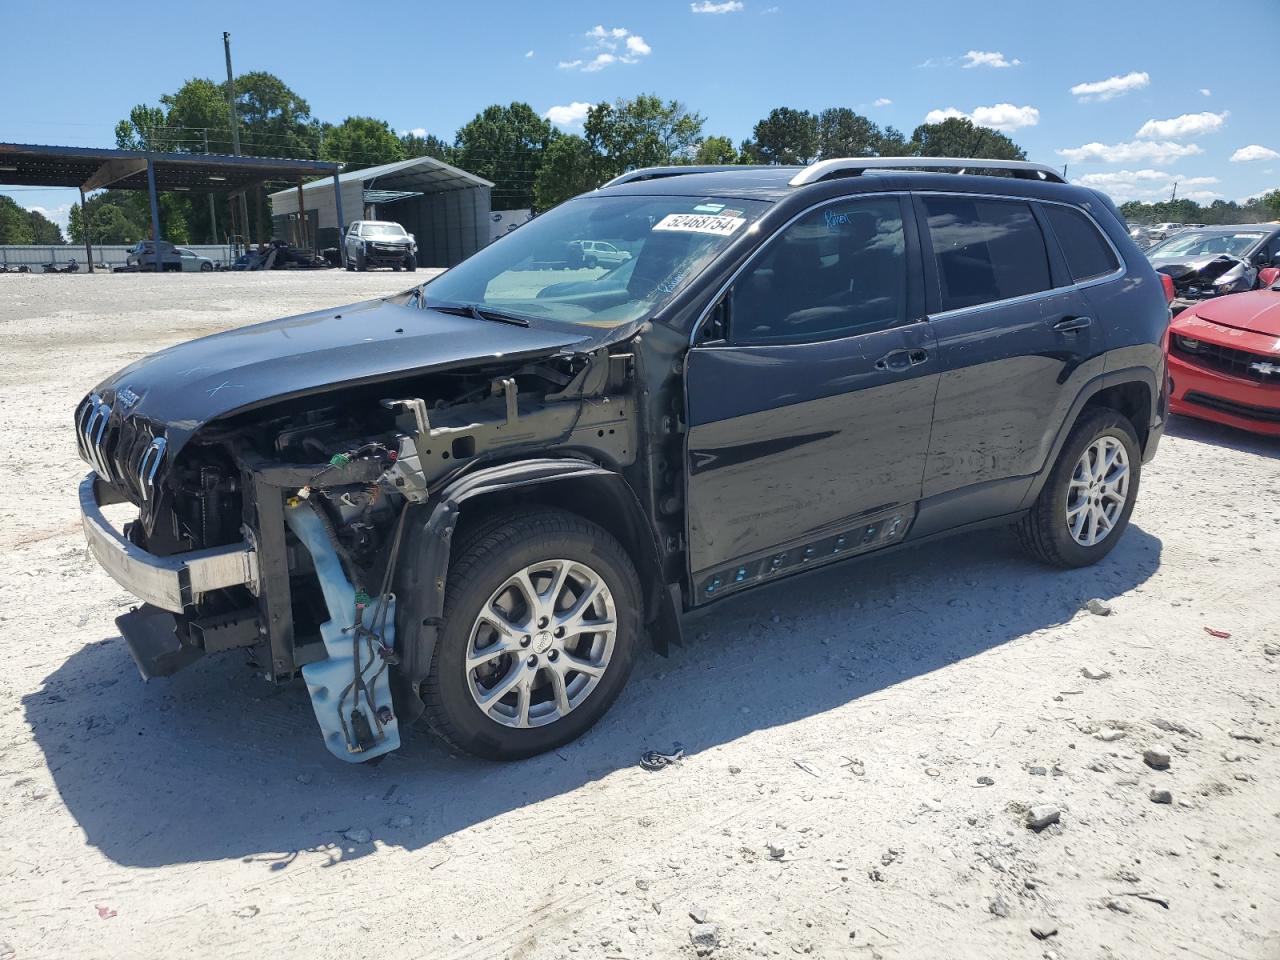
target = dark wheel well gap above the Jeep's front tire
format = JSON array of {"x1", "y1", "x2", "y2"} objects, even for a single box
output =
[{"x1": 449, "y1": 476, "x2": 666, "y2": 639}]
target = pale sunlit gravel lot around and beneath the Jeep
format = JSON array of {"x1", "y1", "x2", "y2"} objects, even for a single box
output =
[{"x1": 0, "y1": 271, "x2": 1280, "y2": 960}]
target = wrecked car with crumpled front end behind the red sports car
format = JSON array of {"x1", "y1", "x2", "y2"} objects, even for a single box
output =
[{"x1": 1147, "y1": 223, "x2": 1280, "y2": 314}]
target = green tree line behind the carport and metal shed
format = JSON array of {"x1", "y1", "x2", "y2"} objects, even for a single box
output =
[{"x1": 69, "y1": 70, "x2": 1027, "y2": 243}]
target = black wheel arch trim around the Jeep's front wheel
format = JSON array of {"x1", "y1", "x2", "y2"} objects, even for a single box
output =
[{"x1": 392, "y1": 457, "x2": 681, "y2": 722}]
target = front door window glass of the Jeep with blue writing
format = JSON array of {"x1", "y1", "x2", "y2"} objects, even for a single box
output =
[{"x1": 728, "y1": 197, "x2": 906, "y2": 343}]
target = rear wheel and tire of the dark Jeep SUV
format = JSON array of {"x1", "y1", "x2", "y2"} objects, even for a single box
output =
[{"x1": 1015, "y1": 408, "x2": 1142, "y2": 567}]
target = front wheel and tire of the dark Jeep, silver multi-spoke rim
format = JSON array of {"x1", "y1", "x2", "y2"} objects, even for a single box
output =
[{"x1": 422, "y1": 509, "x2": 641, "y2": 760}]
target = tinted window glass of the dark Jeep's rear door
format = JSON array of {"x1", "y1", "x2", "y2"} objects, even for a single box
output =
[{"x1": 923, "y1": 196, "x2": 1053, "y2": 310}]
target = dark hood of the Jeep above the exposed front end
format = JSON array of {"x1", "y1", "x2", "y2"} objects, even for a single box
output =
[{"x1": 82, "y1": 300, "x2": 588, "y2": 456}]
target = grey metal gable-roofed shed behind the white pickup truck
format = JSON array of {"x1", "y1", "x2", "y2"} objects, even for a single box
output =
[{"x1": 271, "y1": 156, "x2": 493, "y2": 266}]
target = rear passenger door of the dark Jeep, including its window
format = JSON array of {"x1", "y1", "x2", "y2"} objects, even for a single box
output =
[{"x1": 915, "y1": 193, "x2": 1105, "y2": 534}]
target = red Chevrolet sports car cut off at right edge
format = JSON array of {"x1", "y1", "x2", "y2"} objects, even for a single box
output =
[{"x1": 1169, "y1": 270, "x2": 1280, "y2": 436}]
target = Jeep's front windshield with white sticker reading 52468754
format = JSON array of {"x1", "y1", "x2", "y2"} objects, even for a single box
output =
[{"x1": 424, "y1": 196, "x2": 768, "y2": 326}]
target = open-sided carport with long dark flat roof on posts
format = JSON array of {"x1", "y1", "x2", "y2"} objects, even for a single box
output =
[{"x1": 0, "y1": 143, "x2": 342, "y2": 273}]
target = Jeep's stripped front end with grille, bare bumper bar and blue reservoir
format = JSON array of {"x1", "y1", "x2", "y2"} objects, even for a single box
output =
[{"x1": 77, "y1": 337, "x2": 637, "y2": 762}]
